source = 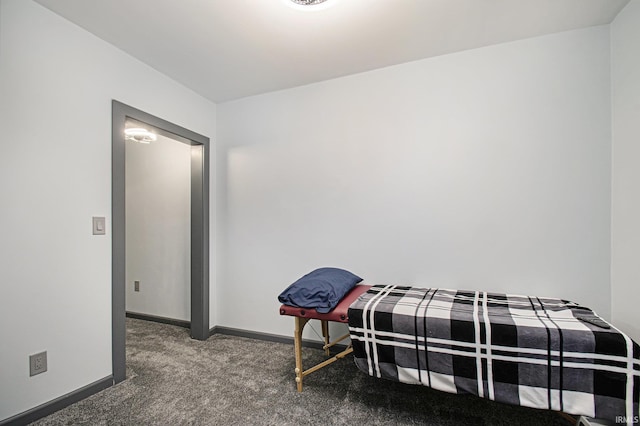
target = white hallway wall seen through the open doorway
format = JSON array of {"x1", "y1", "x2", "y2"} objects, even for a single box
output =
[{"x1": 125, "y1": 135, "x2": 191, "y2": 321}]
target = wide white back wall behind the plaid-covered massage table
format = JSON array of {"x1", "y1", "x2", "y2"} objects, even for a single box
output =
[{"x1": 217, "y1": 26, "x2": 611, "y2": 335}]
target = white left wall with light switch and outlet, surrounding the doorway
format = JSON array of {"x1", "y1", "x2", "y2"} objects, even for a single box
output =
[{"x1": 0, "y1": 0, "x2": 216, "y2": 420}]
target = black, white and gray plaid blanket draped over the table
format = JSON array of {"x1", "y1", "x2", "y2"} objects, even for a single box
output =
[{"x1": 349, "y1": 285, "x2": 640, "y2": 424}]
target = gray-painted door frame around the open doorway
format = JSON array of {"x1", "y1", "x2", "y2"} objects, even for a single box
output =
[{"x1": 111, "y1": 100, "x2": 209, "y2": 383}]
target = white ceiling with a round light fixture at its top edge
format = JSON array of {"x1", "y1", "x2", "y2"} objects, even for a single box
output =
[{"x1": 36, "y1": 0, "x2": 629, "y2": 102}]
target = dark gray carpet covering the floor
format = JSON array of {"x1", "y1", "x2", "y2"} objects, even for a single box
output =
[{"x1": 34, "y1": 318, "x2": 569, "y2": 426}]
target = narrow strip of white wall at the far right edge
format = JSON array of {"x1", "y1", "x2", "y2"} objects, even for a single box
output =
[{"x1": 611, "y1": 0, "x2": 640, "y2": 342}]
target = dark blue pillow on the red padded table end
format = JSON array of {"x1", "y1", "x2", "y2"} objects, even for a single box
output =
[{"x1": 278, "y1": 268, "x2": 362, "y2": 314}]
